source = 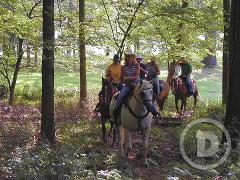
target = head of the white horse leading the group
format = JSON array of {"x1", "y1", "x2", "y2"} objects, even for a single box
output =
[{"x1": 134, "y1": 81, "x2": 153, "y2": 111}]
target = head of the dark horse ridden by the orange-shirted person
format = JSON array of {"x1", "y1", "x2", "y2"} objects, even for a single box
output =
[{"x1": 102, "y1": 77, "x2": 112, "y2": 105}]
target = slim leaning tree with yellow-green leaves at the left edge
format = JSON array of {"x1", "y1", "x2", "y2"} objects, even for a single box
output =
[{"x1": 0, "y1": 0, "x2": 42, "y2": 105}]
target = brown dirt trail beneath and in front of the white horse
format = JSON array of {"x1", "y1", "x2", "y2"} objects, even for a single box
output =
[{"x1": 105, "y1": 115, "x2": 183, "y2": 180}]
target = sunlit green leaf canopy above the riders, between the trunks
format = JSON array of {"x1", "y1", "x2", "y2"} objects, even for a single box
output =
[{"x1": 52, "y1": 0, "x2": 223, "y2": 65}]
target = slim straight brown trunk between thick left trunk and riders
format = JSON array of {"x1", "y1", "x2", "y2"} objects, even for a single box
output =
[{"x1": 79, "y1": 0, "x2": 87, "y2": 101}]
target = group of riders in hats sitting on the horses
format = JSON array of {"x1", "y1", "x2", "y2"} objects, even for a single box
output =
[{"x1": 99, "y1": 53, "x2": 194, "y2": 118}]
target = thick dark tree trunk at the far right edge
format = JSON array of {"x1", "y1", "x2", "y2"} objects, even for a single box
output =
[{"x1": 223, "y1": 0, "x2": 240, "y2": 147}]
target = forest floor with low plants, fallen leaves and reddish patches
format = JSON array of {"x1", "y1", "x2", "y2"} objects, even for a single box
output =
[{"x1": 0, "y1": 99, "x2": 236, "y2": 180}]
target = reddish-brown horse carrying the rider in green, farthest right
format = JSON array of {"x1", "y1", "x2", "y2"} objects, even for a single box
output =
[{"x1": 168, "y1": 61, "x2": 198, "y2": 115}]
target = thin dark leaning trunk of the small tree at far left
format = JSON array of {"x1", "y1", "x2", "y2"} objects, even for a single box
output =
[{"x1": 9, "y1": 38, "x2": 23, "y2": 105}]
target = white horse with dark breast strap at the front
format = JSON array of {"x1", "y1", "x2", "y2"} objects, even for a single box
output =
[{"x1": 110, "y1": 81, "x2": 153, "y2": 165}]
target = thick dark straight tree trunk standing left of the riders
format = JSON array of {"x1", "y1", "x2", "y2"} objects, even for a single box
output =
[{"x1": 41, "y1": 0, "x2": 55, "y2": 143}]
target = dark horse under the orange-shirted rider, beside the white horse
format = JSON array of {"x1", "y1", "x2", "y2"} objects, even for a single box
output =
[{"x1": 99, "y1": 77, "x2": 118, "y2": 144}]
